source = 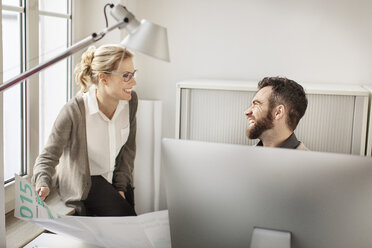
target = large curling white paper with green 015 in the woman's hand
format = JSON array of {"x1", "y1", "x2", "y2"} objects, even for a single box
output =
[{"x1": 15, "y1": 174, "x2": 171, "y2": 248}]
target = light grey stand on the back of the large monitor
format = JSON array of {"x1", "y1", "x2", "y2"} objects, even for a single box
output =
[{"x1": 250, "y1": 227, "x2": 291, "y2": 248}]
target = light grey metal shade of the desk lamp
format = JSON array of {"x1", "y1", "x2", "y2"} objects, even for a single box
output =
[{"x1": 121, "y1": 20, "x2": 170, "y2": 62}]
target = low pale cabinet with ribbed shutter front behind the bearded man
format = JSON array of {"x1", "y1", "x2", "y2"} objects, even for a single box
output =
[{"x1": 176, "y1": 80, "x2": 368, "y2": 155}]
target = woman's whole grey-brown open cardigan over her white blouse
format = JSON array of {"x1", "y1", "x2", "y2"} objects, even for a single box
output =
[{"x1": 32, "y1": 91, "x2": 138, "y2": 213}]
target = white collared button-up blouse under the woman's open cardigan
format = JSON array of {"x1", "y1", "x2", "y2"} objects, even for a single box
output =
[{"x1": 83, "y1": 85, "x2": 130, "y2": 183}]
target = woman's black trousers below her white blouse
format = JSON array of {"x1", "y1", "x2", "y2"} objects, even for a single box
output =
[{"x1": 82, "y1": 176, "x2": 137, "y2": 216}]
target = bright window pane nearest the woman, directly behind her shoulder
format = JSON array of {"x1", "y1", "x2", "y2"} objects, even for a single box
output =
[{"x1": 39, "y1": 0, "x2": 71, "y2": 150}]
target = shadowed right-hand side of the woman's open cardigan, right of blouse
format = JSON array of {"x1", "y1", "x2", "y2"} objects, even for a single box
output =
[{"x1": 112, "y1": 91, "x2": 138, "y2": 192}]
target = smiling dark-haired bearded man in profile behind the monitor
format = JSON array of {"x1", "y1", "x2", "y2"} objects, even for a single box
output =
[{"x1": 244, "y1": 77, "x2": 308, "y2": 150}]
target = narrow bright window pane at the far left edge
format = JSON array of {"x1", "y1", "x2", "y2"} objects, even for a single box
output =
[{"x1": 2, "y1": 1, "x2": 25, "y2": 182}]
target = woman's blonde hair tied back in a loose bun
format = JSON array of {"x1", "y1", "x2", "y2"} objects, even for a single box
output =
[{"x1": 75, "y1": 45, "x2": 133, "y2": 92}]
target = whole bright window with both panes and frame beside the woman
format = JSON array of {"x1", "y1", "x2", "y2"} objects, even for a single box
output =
[{"x1": 1, "y1": 0, "x2": 72, "y2": 211}]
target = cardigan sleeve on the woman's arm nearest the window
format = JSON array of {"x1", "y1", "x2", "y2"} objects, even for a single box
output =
[{"x1": 32, "y1": 100, "x2": 72, "y2": 188}]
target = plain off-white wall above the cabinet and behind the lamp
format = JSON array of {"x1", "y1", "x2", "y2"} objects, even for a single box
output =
[{"x1": 76, "y1": 0, "x2": 372, "y2": 209}]
